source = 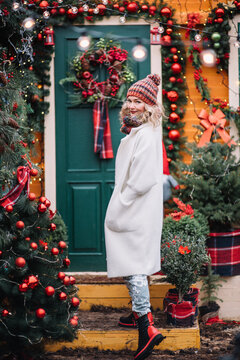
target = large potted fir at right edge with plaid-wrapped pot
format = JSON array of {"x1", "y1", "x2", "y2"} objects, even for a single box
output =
[{"x1": 179, "y1": 142, "x2": 240, "y2": 276}]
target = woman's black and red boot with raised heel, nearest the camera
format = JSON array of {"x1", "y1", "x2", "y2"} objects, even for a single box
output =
[{"x1": 134, "y1": 313, "x2": 165, "y2": 360}]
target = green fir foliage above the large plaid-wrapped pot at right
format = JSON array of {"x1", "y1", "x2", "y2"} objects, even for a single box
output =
[{"x1": 179, "y1": 142, "x2": 240, "y2": 232}]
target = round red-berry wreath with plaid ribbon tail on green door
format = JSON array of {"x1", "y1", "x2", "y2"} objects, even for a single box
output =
[{"x1": 60, "y1": 38, "x2": 135, "y2": 159}]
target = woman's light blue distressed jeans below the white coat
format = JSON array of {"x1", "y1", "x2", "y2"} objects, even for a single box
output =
[{"x1": 124, "y1": 275, "x2": 151, "y2": 316}]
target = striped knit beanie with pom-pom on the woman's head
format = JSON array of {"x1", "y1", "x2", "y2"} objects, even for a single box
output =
[{"x1": 127, "y1": 74, "x2": 160, "y2": 105}]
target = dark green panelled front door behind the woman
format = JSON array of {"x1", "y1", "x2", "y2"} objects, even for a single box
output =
[{"x1": 55, "y1": 25, "x2": 150, "y2": 271}]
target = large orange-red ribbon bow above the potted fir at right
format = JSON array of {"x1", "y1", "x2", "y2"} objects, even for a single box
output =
[{"x1": 198, "y1": 109, "x2": 237, "y2": 147}]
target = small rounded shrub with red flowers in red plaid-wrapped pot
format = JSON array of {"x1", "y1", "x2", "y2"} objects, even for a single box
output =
[{"x1": 162, "y1": 198, "x2": 209, "y2": 326}]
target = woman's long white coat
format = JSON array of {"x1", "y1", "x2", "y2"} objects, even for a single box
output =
[{"x1": 105, "y1": 123, "x2": 163, "y2": 277}]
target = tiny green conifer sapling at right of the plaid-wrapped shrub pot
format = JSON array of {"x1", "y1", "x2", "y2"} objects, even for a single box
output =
[{"x1": 201, "y1": 261, "x2": 226, "y2": 306}]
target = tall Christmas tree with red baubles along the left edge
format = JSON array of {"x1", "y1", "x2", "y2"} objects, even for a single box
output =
[{"x1": 0, "y1": 21, "x2": 79, "y2": 359}]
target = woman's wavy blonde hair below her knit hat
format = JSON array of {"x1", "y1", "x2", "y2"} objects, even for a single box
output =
[{"x1": 120, "y1": 101, "x2": 163, "y2": 127}]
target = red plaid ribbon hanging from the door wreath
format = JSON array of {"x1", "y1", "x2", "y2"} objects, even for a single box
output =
[{"x1": 93, "y1": 100, "x2": 113, "y2": 159}]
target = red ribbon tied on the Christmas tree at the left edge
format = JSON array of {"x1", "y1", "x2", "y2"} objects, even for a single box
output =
[{"x1": 0, "y1": 166, "x2": 30, "y2": 208}]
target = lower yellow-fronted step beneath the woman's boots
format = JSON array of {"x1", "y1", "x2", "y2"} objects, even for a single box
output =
[{"x1": 45, "y1": 307, "x2": 200, "y2": 352}]
